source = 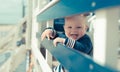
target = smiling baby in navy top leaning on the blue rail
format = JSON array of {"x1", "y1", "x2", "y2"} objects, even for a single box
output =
[{"x1": 41, "y1": 14, "x2": 93, "y2": 72}]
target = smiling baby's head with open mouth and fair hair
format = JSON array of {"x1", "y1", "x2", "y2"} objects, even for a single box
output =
[{"x1": 64, "y1": 15, "x2": 87, "y2": 40}]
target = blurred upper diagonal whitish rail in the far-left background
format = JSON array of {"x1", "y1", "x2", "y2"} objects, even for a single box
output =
[{"x1": 0, "y1": 17, "x2": 26, "y2": 53}]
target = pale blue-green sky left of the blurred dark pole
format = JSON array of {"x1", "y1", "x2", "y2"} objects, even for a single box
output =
[{"x1": 0, "y1": 0, "x2": 23, "y2": 24}]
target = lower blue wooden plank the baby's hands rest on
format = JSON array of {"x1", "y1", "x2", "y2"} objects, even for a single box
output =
[{"x1": 42, "y1": 39, "x2": 117, "y2": 72}]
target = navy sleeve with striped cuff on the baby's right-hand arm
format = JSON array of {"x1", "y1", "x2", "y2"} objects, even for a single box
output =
[{"x1": 64, "y1": 34, "x2": 93, "y2": 54}]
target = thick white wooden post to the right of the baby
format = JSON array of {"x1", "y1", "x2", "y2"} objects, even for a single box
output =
[{"x1": 93, "y1": 7, "x2": 120, "y2": 69}]
